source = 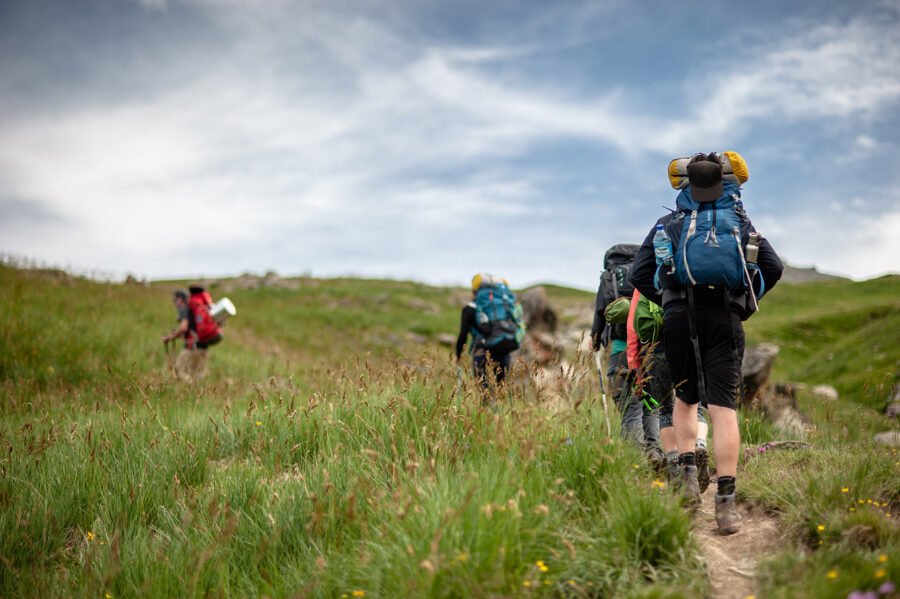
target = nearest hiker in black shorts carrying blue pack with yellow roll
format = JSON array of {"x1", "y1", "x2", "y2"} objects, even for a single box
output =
[{"x1": 631, "y1": 152, "x2": 783, "y2": 534}]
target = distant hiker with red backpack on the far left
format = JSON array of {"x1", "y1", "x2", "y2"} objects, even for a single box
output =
[{"x1": 163, "y1": 285, "x2": 222, "y2": 380}]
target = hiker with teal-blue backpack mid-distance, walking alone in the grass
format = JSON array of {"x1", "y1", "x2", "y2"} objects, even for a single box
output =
[{"x1": 456, "y1": 274, "x2": 525, "y2": 403}]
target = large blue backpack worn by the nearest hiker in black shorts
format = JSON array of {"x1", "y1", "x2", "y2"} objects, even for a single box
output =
[{"x1": 658, "y1": 183, "x2": 752, "y2": 304}]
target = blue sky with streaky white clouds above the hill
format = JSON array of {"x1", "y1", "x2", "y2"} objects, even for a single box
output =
[{"x1": 0, "y1": 0, "x2": 900, "y2": 288}]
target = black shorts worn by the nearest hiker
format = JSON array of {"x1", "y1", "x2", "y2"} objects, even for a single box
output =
[{"x1": 662, "y1": 306, "x2": 744, "y2": 409}]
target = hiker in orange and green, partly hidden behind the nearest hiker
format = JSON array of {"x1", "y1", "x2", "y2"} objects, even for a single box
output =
[{"x1": 625, "y1": 289, "x2": 709, "y2": 493}]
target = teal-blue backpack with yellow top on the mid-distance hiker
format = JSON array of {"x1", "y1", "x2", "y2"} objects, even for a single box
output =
[{"x1": 472, "y1": 276, "x2": 525, "y2": 355}]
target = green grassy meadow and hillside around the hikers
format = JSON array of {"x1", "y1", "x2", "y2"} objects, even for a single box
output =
[{"x1": 0, "y1": 266, "x2": 900, "y2": 598}]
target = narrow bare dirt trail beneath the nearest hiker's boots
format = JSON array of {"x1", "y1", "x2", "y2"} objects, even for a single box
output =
[{"x1": 693, "y1": 490, "x2": 783, "y2": 599}]
